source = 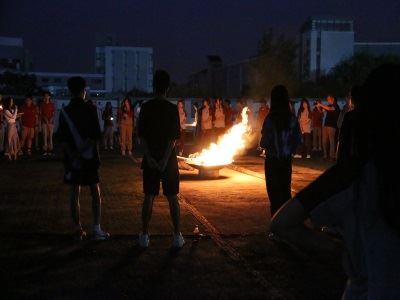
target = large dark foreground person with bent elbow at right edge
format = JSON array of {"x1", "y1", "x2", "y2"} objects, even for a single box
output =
[{"x1": 270, "y1": 64, "x2": 400, "y2": 299}]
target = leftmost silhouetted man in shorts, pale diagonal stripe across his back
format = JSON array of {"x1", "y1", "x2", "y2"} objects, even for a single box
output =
[{"x1": 58, "y1": 77, "x2": 110, "y2": 240}]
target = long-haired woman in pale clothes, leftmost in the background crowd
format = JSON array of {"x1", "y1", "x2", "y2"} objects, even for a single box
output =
[{"x1": 4, "y1": 97, "x2": 20, "y2": 160}]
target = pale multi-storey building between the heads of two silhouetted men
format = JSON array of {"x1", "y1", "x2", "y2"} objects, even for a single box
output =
[{"x1": 96, "y1": 46, "x2": 153, "y2": 93}]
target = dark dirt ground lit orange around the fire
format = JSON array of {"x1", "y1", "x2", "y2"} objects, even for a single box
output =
[{"x1": 0, "y1": 153, "x2": 345, "y2": 299}]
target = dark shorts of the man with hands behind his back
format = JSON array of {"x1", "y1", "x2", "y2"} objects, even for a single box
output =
[{"x1": 142, "y1": 157, "x2": 179, "y2": 196}]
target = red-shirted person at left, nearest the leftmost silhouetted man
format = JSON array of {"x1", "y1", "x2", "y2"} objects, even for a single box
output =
[{"x1": 40, "y1": 92, "x2": 55, "y2": 156}]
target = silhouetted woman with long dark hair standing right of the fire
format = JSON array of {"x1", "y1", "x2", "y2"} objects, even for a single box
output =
[{"x1": 260, "y1": 85, "x2": 301, "y2": 215}]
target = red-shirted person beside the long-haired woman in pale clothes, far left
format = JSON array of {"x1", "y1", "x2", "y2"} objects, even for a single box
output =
[{"x1": 20, "y1": 95, "x2": 37, "y2": 155}]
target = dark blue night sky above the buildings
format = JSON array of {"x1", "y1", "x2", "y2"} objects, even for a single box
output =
[{"x1": 0, "y1": 0, "x2": 400, "y2": 82}]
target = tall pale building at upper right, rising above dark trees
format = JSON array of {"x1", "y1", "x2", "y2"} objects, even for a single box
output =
[{"x1": 298, "y1": 17, "x2": 354, "y2": 80}]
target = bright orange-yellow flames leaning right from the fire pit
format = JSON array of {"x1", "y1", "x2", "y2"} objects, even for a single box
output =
[{"x1": 187, "y1": 107, "x2": 250, "y2": 166}]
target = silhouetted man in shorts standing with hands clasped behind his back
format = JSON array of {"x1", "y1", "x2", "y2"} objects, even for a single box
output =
[{"x1": 139, "y1": 70, "x2": 185, "y2": 248}]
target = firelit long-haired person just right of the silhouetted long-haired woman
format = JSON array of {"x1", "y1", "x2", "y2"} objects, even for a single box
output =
[{"x1": 297, "y1": 98, "x2": 311, "y2": 158}]
